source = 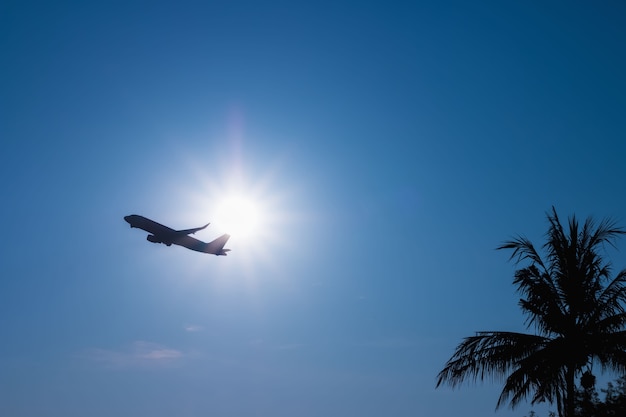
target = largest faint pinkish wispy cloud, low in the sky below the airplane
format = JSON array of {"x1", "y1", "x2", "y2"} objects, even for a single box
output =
[{"x1": 86, "y1": 341, "x2": 184, "y2": 368}]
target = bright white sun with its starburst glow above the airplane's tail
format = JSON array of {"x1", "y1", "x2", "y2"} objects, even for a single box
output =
[{"x1": 174, "y1": 142, "x2": 294, "y2": 272}]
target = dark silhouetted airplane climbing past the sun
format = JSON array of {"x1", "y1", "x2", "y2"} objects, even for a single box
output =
[{"x1": 124, "y1": 214, "x2": 230, "y2": 256}]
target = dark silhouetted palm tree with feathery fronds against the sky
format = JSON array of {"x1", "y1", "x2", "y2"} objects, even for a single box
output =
[{"x1": 437, "y1": 207, "x2": 626, "y2": 417}]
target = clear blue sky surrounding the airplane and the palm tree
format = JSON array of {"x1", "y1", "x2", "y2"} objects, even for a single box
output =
[{"x1": 0, "y1": 1, "x2": 626, "y2": 417}]
